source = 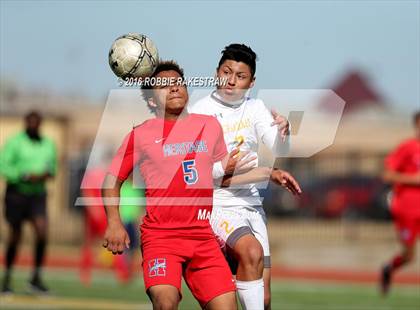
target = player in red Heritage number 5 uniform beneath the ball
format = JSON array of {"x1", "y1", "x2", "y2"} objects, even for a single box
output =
[{"x1": 103, "y1": 62, "x2": 240, "y2": 309}]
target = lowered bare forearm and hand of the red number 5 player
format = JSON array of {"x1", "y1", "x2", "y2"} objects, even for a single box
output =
[{"x1": 102, "y1": 174, "x2": 130, "y2": 255}]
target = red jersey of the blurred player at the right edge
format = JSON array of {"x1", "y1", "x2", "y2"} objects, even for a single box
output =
[{"x1": 385, "y1": 139, "x2": 420, "y2": 217}]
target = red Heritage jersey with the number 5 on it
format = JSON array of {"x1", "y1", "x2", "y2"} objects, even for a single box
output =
[{"x1": 109, "y1": 114, "x2": 227, "y2": 235}]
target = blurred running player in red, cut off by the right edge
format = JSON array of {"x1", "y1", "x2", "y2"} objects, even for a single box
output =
[{"x1": 381, "y1": 112, "x2": 420, "y2": 294}]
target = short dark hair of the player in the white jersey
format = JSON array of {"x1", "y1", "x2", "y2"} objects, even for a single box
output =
[{"x1": 217, "y1": 43, "x2": 257, "y2": 77}]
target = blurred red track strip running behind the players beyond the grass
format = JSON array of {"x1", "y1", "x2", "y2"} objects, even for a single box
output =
[{"x1": 0, "y1": 255, "x2": 420, "y2": 285}]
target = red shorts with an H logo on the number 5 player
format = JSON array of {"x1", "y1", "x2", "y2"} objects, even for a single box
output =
[{"x1": 141, "y1": 229, "x2": 236, "y2": 307}]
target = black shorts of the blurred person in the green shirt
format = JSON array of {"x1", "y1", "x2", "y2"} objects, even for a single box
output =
[{"x1": 5, "y1": 185, "x2": 47, "y2": 226}]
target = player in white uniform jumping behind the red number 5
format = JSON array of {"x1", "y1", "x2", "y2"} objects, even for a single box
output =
[{"x1": 189, "y1": 44, "x2": 296, "y2": 310}]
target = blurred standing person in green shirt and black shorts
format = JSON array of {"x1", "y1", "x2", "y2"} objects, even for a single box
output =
[{"x1": 0, "y1": 111, "x2": 57, "y2": 293}]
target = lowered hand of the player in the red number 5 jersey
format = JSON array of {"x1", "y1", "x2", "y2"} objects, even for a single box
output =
[{"x1": 102, "y1": 222, "x2": 130, "y2": 255}]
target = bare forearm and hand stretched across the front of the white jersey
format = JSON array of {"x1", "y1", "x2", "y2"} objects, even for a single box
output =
[{"x1": 222, "y1": 167, "x2": 302, "y2": 195}]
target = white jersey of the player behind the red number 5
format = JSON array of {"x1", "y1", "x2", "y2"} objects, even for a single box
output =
[{"x1": 188, "y1": 92, "x2": 288, "y2": 207}]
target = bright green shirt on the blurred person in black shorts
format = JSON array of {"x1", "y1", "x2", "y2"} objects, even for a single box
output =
[{"x1": 0, "y1": 132, "x2": 57, "y2": 194}]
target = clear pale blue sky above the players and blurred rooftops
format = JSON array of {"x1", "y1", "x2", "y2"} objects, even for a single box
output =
[{"x1": 0, "y1": 0, "x2": 420, "y2": 112}]
